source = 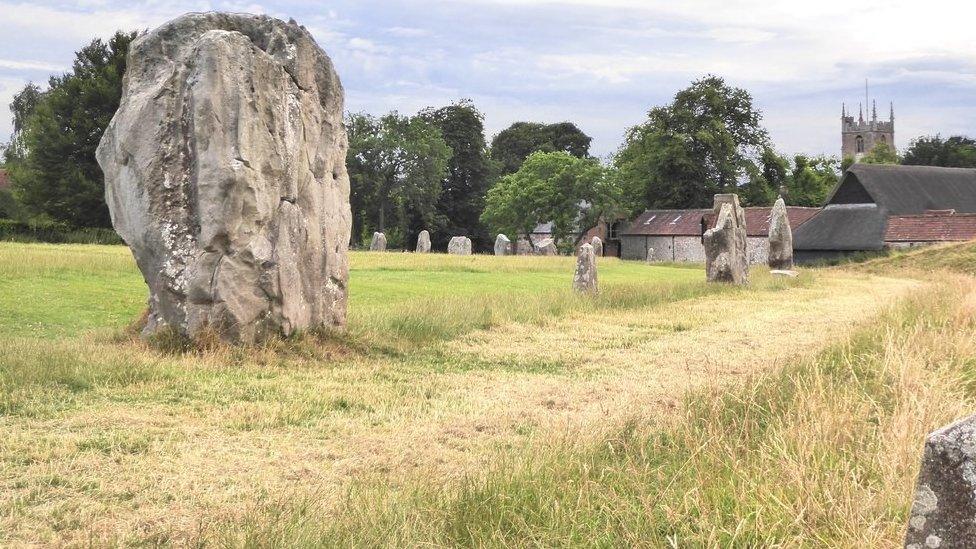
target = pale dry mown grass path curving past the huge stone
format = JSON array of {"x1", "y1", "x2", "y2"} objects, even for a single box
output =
[{"x1": 0, "y1": 266, "x2": 920, "y2": 543}]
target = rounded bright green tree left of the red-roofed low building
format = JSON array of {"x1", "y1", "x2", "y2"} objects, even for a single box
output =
[{"x1": 481, "y1": 151, "x2": 619, "y2": 243}]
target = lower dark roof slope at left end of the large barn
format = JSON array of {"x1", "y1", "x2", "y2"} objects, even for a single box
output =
[{"x1": 793, "y1": 204, "x2": 888, "y2": 251}]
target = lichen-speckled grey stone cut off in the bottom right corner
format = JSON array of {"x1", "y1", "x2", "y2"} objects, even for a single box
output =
[{"x1": 905, "y1": 415, "x2": 976, "y2": 549}]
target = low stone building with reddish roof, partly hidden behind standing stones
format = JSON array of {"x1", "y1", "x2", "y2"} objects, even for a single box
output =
[{"x1": 619, "y1": 206, "x2": 819, "y2": 263}]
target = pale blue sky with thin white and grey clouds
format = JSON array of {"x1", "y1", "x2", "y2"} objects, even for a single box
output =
[{"x1": 0, "y1": 0, "x2": 976, "y2": 158}]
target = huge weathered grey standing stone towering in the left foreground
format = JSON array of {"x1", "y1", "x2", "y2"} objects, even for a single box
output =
[{"x1": 96, "y1": 13, "x2": 352, "y2": 342}]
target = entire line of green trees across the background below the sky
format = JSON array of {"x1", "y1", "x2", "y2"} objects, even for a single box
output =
[{"x1": 0, "y1": 32, "x2": 976, "y2": 249}]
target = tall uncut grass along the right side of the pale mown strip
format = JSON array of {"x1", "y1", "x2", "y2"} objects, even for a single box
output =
[{"x1": 202, "y1": 275, "x2": 976, "y2": 547}]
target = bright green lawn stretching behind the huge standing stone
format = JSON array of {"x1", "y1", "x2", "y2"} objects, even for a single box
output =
[{"x1": 0, "y1": 242, "x2": 704, "y2": 340}]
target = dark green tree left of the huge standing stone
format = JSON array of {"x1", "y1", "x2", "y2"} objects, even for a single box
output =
[{"x1": 5, "y1": 32, "x2": 136, "y2": 227}]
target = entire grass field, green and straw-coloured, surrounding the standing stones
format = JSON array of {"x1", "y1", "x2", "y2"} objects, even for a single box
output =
[{"x1": 0, "y1": 244, "x2": 976, "y2": 547}]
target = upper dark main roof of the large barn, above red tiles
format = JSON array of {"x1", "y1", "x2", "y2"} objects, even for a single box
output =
[{"x1": 827, "y1": 163, "x2": 976, "y2": 215}]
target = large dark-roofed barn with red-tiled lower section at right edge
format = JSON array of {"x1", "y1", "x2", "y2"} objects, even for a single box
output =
[{"x1": 793, "y1": 164, "x2": 976, "y2": 262}]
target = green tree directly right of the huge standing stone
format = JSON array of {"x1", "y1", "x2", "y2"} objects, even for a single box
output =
[{"x1": 346, "y1": 112, "x2": 451, "y2": 246}]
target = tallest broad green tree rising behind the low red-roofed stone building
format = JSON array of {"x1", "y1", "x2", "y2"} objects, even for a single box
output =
[{"x1": 614, "y1": 76, "x2": 776, "y2": 212}]
